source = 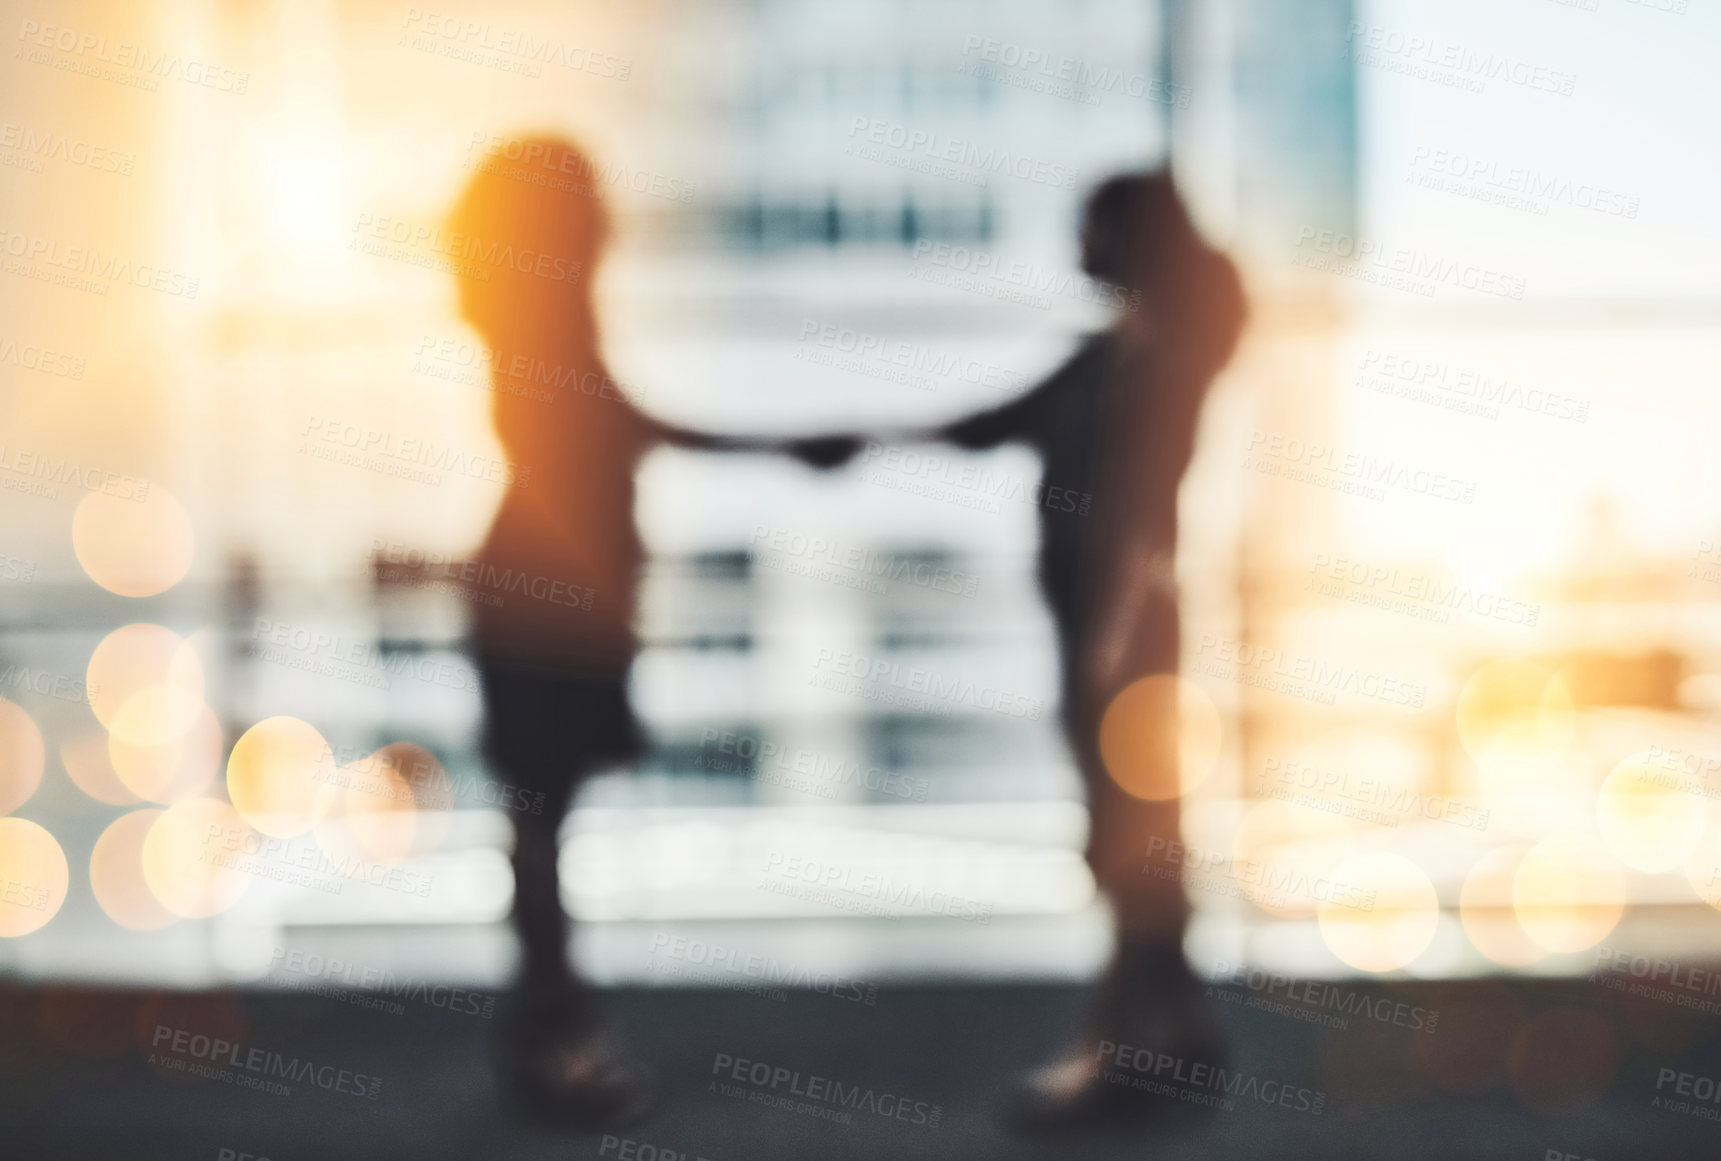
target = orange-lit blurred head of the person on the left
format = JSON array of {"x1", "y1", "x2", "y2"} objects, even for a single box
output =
[{"x1": 447, "y1": 136, "x2": 609, "y2": 342}]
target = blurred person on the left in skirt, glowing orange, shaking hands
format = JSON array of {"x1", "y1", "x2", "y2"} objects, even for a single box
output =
[{"x1": 444, "y1": 138, "x2": 846, "y2": 1125}]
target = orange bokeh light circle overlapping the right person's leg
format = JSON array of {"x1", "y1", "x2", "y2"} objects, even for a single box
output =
[{"x1": 1100, "y1": 674, "x2": 1224, "y2": 802}]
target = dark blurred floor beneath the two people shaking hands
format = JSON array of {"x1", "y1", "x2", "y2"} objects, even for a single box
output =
[{"x1": 0, "y1": 982, "x2": 1721, "y2": 1161}]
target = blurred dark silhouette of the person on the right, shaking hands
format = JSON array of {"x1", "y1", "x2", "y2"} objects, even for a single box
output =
[{"x1": 894, "y1": 172, "x2": 1244, "y2": 1128}]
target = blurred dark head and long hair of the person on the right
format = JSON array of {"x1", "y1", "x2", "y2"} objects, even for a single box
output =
[{"x1": 1081, "y1": 169, "x2": 1244, "y2": 373}]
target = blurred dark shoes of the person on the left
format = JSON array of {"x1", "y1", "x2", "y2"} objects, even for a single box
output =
[{"x1": 503, "y1": 1034, "x2": 654, "y2": 1128}]
